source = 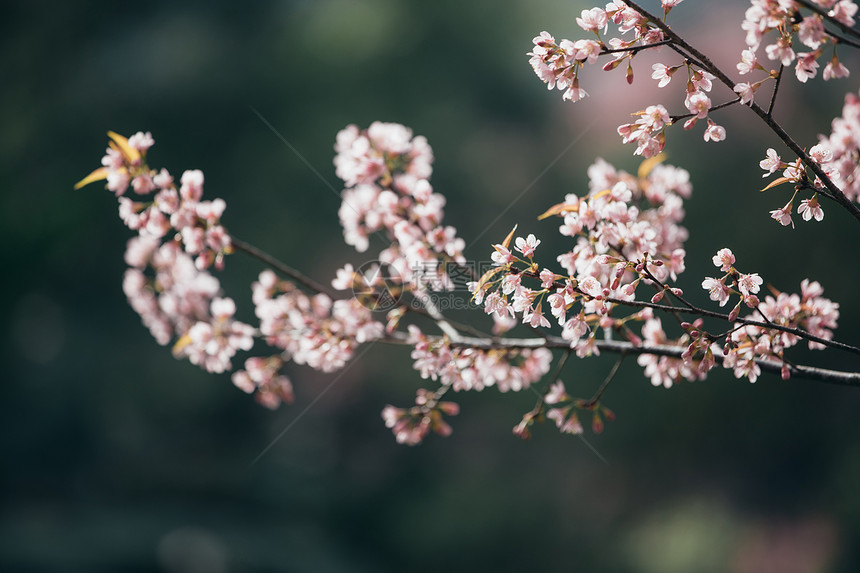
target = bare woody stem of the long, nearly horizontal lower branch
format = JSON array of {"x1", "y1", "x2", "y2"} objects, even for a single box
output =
[{"x1": 378, "y1": 332, "x2": 860, "y2": 387}]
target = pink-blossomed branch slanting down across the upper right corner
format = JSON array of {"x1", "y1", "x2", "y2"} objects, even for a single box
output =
[{"x1": 529, "y1": 0, "x2": 860, "y2": 219}]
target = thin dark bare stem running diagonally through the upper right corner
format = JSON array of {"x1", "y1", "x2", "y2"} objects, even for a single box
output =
[{"x1": 625, "y1": 0, "x2": 860, "y2": 221}]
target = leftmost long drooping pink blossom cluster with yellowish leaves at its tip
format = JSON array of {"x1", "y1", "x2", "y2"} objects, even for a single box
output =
[{"x1": 76, "y1": 132, "x2": 254, "y2": 378}]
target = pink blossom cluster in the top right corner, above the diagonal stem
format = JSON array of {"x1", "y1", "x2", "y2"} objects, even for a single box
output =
[{"x1": 735, "y1": 0, "x2": 857, "y2": 95}]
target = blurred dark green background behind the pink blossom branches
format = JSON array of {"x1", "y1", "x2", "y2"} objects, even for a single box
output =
[{"x1": 5, "y1": 0, "x2": 860, "y2": 573}]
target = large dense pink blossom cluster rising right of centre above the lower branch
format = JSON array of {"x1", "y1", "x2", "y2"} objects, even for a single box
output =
[{"x1": 471, "y1": 154, "x2": 691, "y2": 356}]
